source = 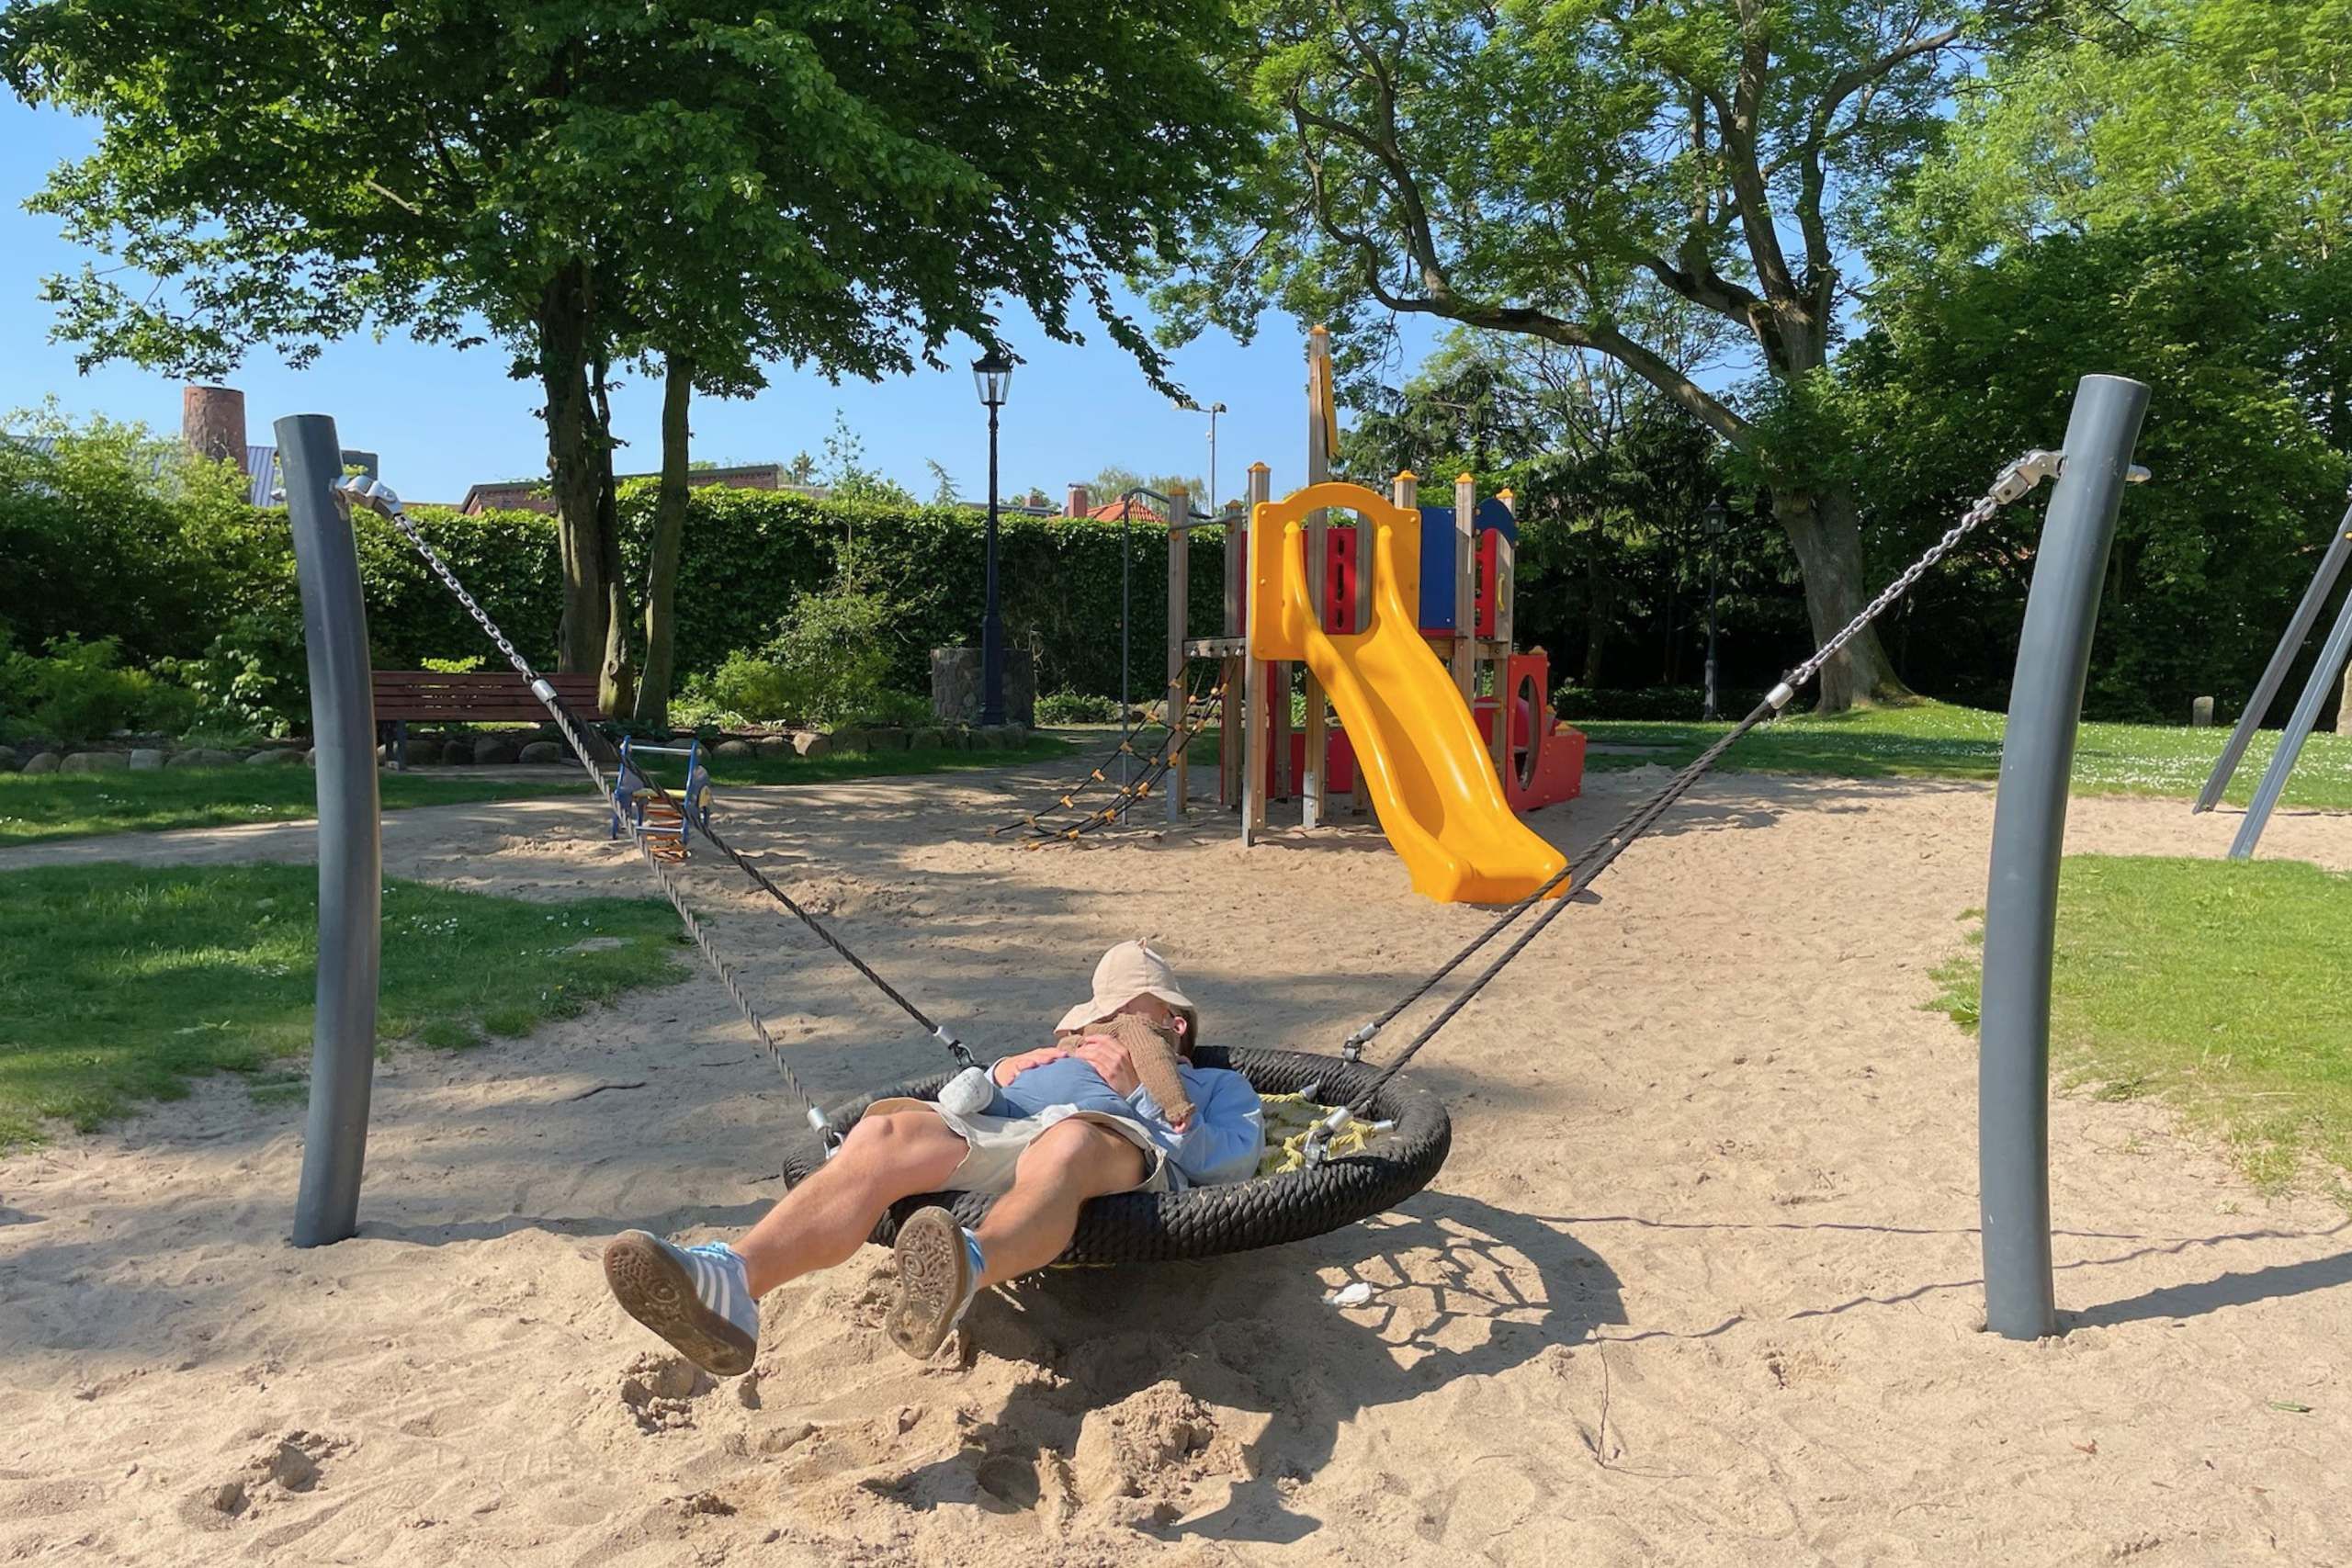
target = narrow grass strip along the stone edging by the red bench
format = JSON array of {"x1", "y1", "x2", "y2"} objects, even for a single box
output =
[{"x1": 0, "y1": 736, "x2": 1068, "y2": 849}]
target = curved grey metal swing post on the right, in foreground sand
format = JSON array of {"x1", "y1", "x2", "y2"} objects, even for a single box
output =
[{"x1": 1975, "y1": 376, "x2": 2147, "y2": 1340}]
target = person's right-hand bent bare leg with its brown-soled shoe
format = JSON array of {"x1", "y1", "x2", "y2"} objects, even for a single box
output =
[{"x1": 882, "y1": 1119, "x2": 1146, "y2": 1359}]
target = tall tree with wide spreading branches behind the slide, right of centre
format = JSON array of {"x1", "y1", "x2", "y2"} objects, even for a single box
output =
[{"x1": 1162, "y1": 0, "x2": 2020, "y2": 710}]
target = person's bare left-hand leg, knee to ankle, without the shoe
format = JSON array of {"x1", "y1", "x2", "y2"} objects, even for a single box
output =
[{"x1": 731, "y1": 1110, "x2": 967, "y2": 1295}]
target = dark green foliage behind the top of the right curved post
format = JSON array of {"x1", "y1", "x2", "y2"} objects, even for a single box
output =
[{"x1": 1841, "y1": 214, "x2": 2345, "y2": 719}]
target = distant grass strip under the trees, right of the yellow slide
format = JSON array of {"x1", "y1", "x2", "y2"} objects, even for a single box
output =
[{"x1": 1571, "y1": 703, "x2": 2352, "y2": 807}]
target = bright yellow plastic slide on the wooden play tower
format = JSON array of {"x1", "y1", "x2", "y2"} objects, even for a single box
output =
[{"x1": 1249, "y1": 482, "x2": 1566, "y2": 903}]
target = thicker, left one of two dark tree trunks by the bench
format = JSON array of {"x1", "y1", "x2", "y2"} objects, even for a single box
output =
[{"x1": 538, "y1": 261, "x2": 612, "y2": 672}]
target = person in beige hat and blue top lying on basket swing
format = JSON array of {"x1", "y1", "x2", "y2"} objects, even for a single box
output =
[{"x1": 605, "y1": 942, "x2": 1265, "y2": 1378}]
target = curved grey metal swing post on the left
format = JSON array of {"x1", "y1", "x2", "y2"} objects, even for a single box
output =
[{"x1": 277, "y1": 413, "x2": 383, "y2": 1246}]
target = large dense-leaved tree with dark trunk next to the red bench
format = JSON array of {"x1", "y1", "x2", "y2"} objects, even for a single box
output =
[{"x1": 0, "y1": 0, "x2": 1249, "y2": 696}]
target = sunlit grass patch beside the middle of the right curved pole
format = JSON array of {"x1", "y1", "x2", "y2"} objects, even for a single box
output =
[{"x1": 1933, "y1": 856, "x2": 2352, "y2": 1187}]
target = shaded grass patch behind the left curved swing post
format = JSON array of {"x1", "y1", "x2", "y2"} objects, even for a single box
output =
[{"x1": 0, "y1": 865, "x2": 687, "y2": 1152}]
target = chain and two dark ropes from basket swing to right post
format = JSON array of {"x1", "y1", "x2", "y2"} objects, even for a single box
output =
[{"x1": 1307, "y1": 449, "x2": 2063, "y2": 1152}]
